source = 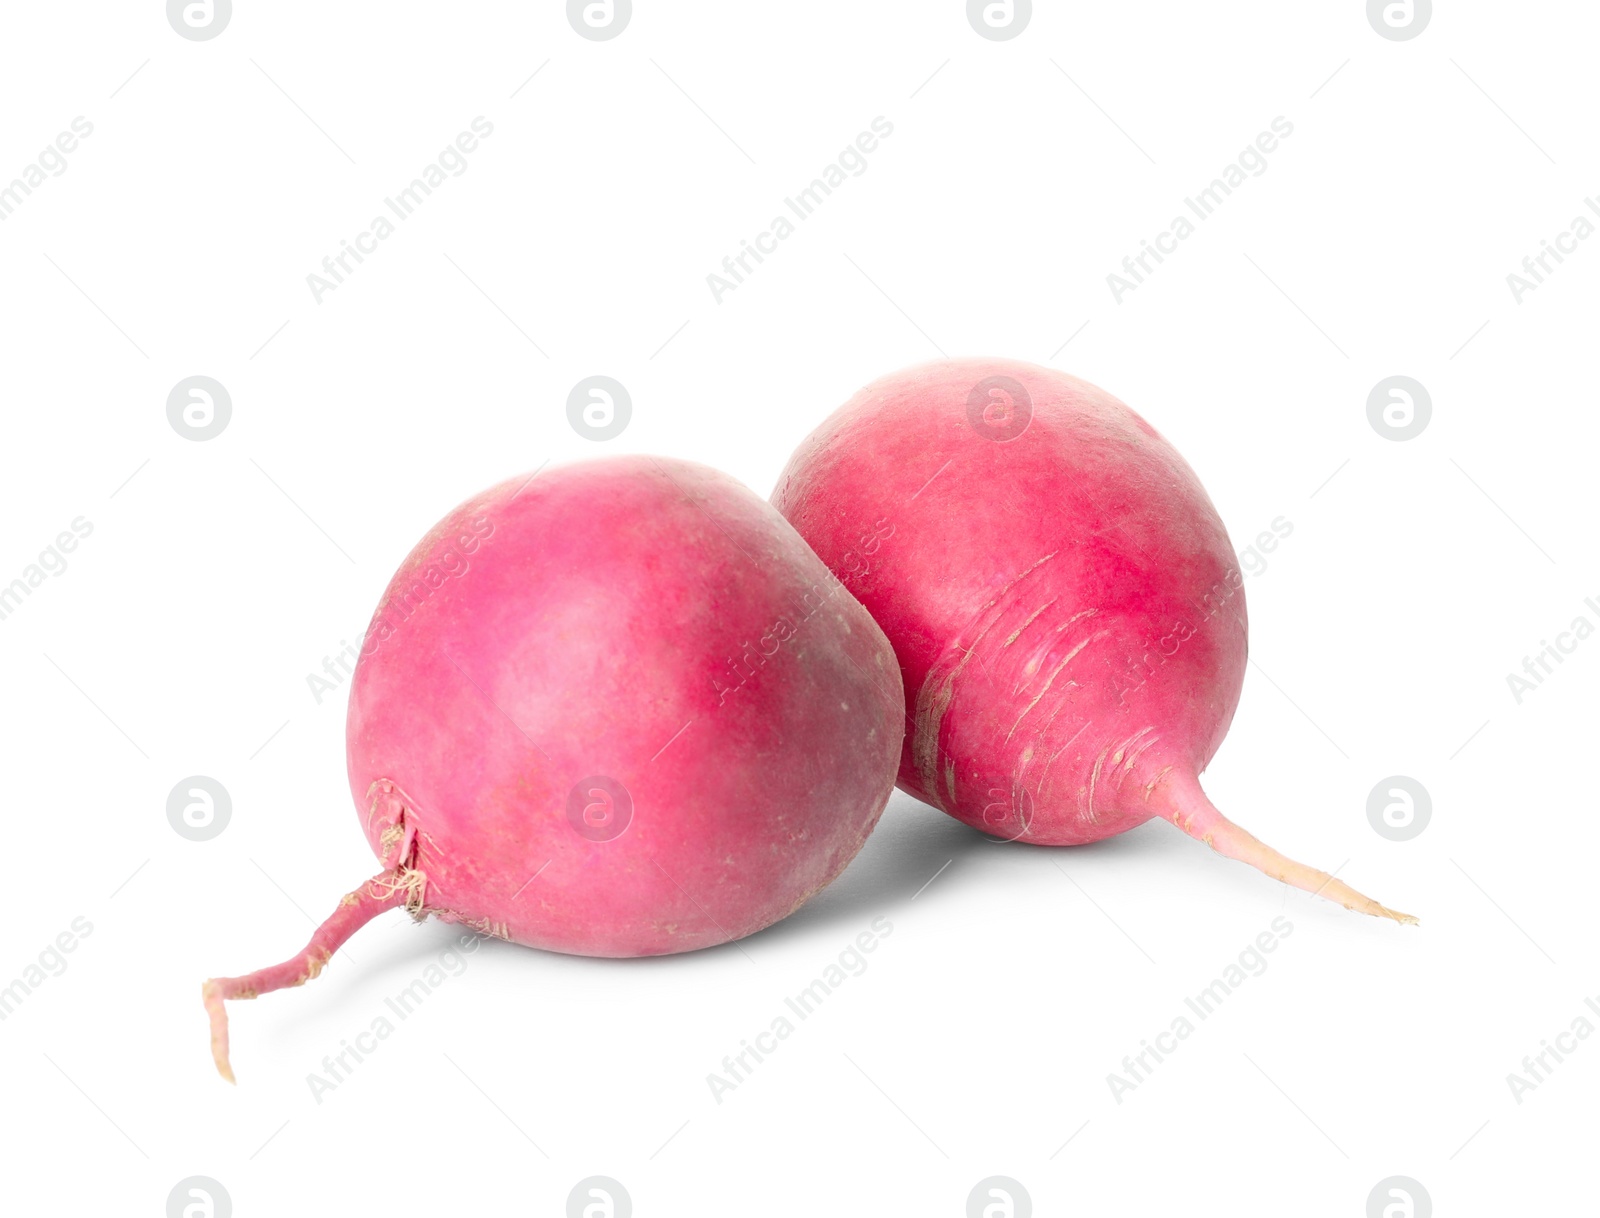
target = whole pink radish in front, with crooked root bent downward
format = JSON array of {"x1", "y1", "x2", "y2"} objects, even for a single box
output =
[{"x1": 205, "y1": 456, "x2": 906, "y2": 1079}]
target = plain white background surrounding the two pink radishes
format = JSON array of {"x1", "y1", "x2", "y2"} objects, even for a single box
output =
[{"x1": 0, "y1": 0, "x2": 1600, "y2": 1218}]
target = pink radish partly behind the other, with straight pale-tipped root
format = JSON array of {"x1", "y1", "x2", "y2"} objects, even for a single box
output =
[{"x1": 773, "y1": 359, "x2": 1414, "y2": 922}]
